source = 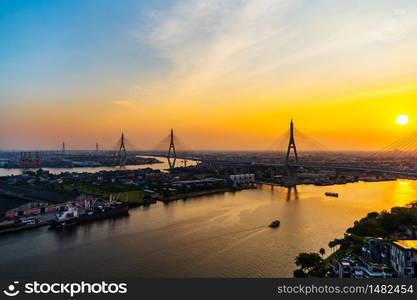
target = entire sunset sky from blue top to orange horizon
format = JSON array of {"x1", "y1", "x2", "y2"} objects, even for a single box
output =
[{"x1": 0, "y1": 0, "x2": 417, "y2": 150}]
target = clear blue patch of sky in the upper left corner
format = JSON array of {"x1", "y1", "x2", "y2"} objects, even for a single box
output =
[{"x1": 0, "y1": 0, "x2": 167, "y2": 101}]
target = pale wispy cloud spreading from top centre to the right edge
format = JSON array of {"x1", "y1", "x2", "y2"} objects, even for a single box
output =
[{"x1": 141, "y1": 0, "x2": 417, "y2": 99}]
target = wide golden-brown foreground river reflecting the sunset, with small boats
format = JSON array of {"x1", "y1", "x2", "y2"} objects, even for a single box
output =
[{"x1": 0, "y1": 175, "x2": 417, "y2": 280}]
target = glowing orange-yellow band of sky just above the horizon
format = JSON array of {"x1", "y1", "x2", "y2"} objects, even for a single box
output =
[{"x1": 3, "y1": 78, "x2": 417, "y2": 150}]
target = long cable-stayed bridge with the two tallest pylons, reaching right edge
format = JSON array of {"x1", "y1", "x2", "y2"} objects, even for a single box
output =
[{"x1": 120, "y1": 120, "x2": 417, "y2": 177}]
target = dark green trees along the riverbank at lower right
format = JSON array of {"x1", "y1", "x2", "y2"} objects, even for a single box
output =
[{"x1": 294, "y1": 201, "x2": 417, "y2": 278}]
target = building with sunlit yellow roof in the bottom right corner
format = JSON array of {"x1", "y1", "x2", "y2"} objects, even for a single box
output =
[{"x1": 390, "y1": 240, "x2": 417, "y2": 278}]
